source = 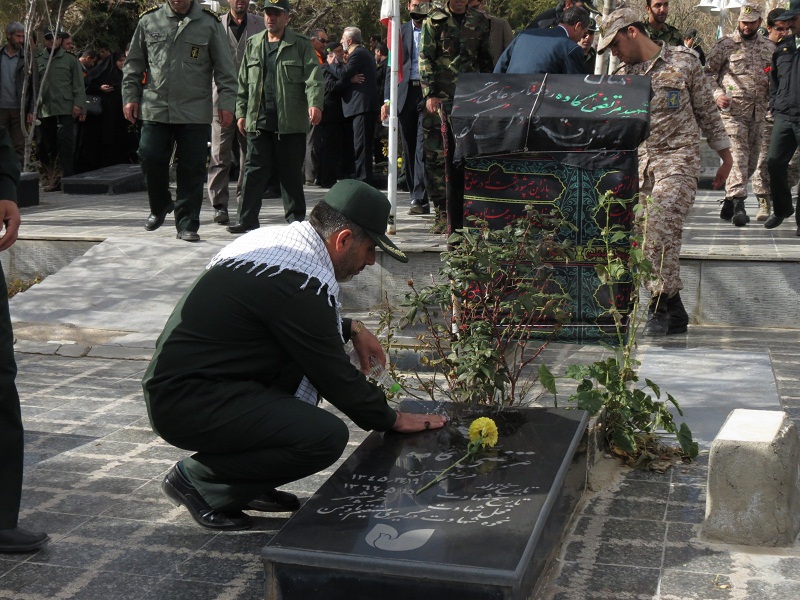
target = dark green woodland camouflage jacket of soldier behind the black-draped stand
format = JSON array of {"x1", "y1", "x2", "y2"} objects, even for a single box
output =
[{"x1": 419, "y1": 7, "x2": 494, "y2": 101}]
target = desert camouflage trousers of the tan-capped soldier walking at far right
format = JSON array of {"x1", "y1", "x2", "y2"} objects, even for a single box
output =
[{"x1": 720, "y1": 111, "x2": 764, "y2": 198}]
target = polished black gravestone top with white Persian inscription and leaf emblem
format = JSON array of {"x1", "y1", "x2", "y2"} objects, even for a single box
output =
[{"x1": 268, "y1": 409, "x2": 585, "y2": 568}]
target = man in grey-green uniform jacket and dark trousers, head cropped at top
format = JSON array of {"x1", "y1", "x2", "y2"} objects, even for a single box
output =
[{"x1": 122, "y1": 0, "x2": 236, "y2": 242}]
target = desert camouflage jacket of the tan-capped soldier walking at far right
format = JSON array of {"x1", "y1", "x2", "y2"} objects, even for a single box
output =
[{"x1": 706, "y1": 31, "x2": 775, "y2": 117}]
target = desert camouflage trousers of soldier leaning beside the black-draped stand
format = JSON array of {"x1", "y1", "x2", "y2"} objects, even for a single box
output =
[{"x1": 637, "y1": 149, "x2": 700, "y2": 296}]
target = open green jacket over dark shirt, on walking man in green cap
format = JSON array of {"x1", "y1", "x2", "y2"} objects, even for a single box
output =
[{"x1": 236, "y1": 28, "x2": 325, "y2": 134}]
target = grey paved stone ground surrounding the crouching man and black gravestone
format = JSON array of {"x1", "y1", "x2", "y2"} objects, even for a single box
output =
[{"x1": 0, "y1": 183, "x2": 800, "y2": 600}]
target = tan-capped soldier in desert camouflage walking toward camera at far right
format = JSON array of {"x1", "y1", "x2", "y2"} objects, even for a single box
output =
[{"x1": 706, "y1": 2, "x2": 775, "y2": 227}]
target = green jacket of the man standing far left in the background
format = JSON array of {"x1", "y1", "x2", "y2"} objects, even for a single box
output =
[{"x1": 36, "y1": 48, "x2": 86, "y2": 117}]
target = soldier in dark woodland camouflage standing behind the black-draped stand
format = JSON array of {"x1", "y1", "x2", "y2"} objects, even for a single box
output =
[{"x1": 419, "y1": 0, "x2": 494, "y2": 233}]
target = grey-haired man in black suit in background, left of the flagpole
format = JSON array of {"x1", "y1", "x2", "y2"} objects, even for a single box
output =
[{"x1": 328, "y1": 27, "x2": 378, "y2": 183}]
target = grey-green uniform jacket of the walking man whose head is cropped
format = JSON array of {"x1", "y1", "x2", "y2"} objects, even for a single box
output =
[{"x1": 122, "y1": 3, "x2": 236, "y2": 124}]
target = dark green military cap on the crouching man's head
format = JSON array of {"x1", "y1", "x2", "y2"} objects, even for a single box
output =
[{"x1": 325, "y1": 179, "x2": 408, "y2": 262}]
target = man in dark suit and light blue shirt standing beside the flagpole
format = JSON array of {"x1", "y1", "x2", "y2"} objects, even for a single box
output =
[{"x1": 381, "y1": 0, "x2": 431, "y2": 215}]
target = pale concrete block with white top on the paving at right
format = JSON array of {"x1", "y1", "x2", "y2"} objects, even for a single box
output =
[{"x1": 702, "y1": 409, "x2": 800, "y2": 546}]
